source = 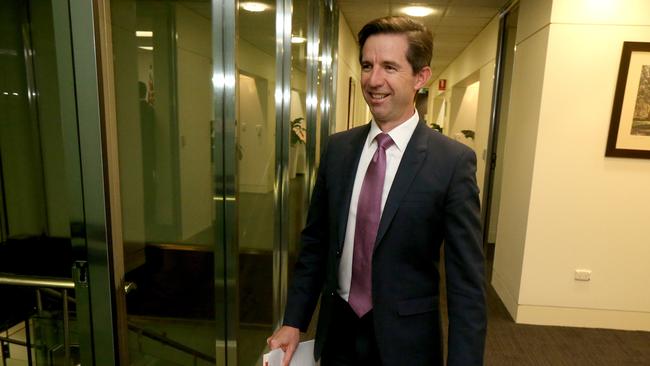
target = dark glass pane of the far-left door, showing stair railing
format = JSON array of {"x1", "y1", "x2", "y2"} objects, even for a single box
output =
[{"x1": 0, "y1": 0, "x2": 92, "y2": 365}]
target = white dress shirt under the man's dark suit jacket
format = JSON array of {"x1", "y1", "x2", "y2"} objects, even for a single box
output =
[{"x1": 338, "y1": 110, "x2": 420, "y2": 301}]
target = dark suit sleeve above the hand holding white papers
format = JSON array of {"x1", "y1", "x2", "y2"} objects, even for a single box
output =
[{"x1": 283, "y1": 145, "x2": 329, "y2": 332}]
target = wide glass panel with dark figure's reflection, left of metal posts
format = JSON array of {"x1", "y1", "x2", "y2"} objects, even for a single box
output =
[{"x1": 111, "y1": 0, "x2": 214, "y2": 365}]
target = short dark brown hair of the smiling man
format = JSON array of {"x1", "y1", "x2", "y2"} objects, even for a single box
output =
[{"x1": 358, "y1": 16, "x2": 433, "y2": 73}]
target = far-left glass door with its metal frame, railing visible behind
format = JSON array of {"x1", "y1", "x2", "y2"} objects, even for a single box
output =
[{"x1": 0, "y1": 0, "x2": 115, "y2": 365}]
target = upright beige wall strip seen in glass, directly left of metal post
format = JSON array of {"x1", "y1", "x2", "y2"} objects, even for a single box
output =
[{"x1": 176, "y1": 6, "x2": 213, "y2": 243}]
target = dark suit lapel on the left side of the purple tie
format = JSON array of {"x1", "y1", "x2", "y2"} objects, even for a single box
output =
[{"x1": 338, "y1": 123, "x2": 370, "y2": 249}]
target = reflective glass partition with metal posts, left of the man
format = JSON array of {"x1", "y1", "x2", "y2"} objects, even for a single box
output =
[{"x1": 105, "y1": 0, "x2": 331, "y2": 366}]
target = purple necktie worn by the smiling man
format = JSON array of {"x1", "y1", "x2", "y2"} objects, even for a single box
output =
[{"x1": 348, "y1": 133, "x2": 393, "y2": 318}]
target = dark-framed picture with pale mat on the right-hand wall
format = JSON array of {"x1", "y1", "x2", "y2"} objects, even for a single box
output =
[{"x1": 605, "y1": 42, "x2": 650, "y2": 159}]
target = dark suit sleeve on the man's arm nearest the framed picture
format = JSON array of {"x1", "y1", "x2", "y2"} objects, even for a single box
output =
[{"x1": 444, "y1": 149, "x2": 487, "y2": 366}]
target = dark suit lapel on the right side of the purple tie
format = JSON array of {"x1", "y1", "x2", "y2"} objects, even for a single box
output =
[{"x1": 375, "y1": 121, "x2": 428, "y2": 247}]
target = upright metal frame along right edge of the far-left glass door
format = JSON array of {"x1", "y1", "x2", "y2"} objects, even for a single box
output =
[{"x1": 69, "y1": 0, "x2": 119, "y2": 365}]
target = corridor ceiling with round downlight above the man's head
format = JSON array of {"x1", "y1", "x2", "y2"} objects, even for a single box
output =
[{"x1": 338, "y1": 0, "x2": 511, "y2": 80}]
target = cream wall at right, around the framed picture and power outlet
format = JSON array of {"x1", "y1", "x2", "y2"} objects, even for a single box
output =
[{"x1": 493, "y1": 0, "x2": 650, "y2": 331}]
